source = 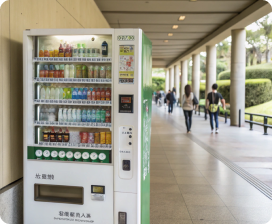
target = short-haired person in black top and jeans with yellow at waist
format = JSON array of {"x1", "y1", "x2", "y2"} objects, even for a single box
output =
[{"x1": 206, "y1": 83, "x2": 226, "y2": 134}]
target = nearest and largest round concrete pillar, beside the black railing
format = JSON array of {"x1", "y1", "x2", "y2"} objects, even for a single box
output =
[{"x1": 230, "y1": 29, "x2": 246, "y2": 126}]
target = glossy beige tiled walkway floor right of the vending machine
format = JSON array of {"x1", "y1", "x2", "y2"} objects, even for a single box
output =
[{"x1": 150, "y1": 106, "x2": 272, "y2": 224}]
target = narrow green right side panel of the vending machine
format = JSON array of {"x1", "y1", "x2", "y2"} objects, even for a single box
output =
[{"x1": 141, "y1": 34, "x2": 152, "y2": 224}]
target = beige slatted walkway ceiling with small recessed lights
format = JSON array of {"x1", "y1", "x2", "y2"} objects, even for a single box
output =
[{"x1": 95, "y1": 0, "x2": 271, "y2": 67}]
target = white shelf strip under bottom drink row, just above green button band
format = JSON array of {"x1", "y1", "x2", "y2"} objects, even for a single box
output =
[{"x1": 32, "y1": 141, "x2": 112, "y2": 150}]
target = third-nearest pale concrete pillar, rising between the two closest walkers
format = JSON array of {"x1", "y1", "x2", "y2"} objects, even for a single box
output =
[{"x1": 192, "y1": 54, "x2": 200, "y2": 99}]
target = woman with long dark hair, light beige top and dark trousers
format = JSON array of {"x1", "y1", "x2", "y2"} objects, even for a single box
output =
[{"x1": 182, "y1": 85, "x2": 195, "y2": 133}]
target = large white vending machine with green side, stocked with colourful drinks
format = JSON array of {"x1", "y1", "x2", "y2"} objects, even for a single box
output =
[{"x1": 23, "y1": 29, "x2": 152, "y2": 224}]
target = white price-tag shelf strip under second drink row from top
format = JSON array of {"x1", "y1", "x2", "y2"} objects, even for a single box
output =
[{"x1": 34, "y1": 77, "x2": 112, "y2": 84}]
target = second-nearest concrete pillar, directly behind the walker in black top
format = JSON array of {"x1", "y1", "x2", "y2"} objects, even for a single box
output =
[{"x1": 205, "y1": 46, "x2": 216, "y2": 98}]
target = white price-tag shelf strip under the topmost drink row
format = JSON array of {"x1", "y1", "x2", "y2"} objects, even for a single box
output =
[{"x1": 33, "y1": 57, "x2": 112, "y2": 63}]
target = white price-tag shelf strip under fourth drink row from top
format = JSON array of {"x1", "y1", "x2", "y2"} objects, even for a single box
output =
[{"x1": 34, "y1": 121, "x2": 111, "y2": 128}]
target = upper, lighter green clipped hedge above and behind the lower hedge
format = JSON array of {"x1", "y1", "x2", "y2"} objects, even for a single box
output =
[{"x1": 218, "y1": 67, "x2": 272, "y2": 81}]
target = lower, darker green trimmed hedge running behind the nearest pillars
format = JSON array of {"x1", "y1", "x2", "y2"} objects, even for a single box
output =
[{"x1": 200, "y1": 79, "x2": 271, "y2": 107}]
